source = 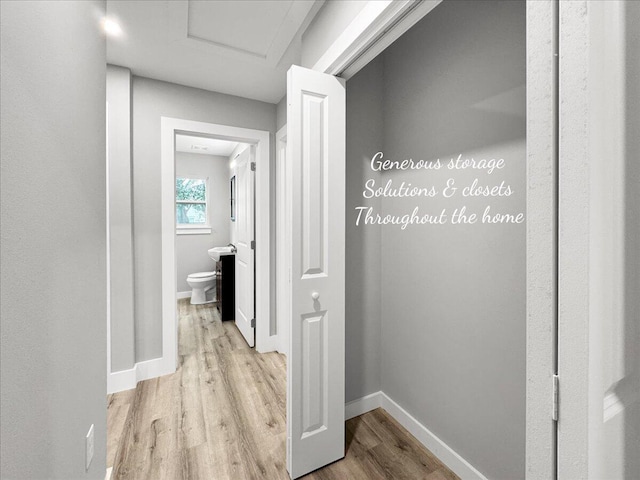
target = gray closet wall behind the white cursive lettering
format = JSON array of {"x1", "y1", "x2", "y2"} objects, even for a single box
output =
[{"x1": 347, "y1": 1, "x2": 526, "y2": 479}]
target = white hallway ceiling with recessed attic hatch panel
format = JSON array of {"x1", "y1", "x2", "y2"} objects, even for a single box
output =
[{"x1": 107, "y1": 0, "x2": 324, "y2": 103}]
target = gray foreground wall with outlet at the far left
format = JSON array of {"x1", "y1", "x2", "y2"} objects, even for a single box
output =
[{"x1": 0, "y1": 1, "x2": 106, "y2": 479}]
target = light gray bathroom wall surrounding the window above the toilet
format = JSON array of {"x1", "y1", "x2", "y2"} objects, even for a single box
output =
[{"x1": 176, "y1": 152, "x2": 231, "y2": 292}]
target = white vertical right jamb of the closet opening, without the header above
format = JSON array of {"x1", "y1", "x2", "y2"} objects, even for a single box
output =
[{"x1": 525, "y1": 0, "x2": 558, "y2": 480}]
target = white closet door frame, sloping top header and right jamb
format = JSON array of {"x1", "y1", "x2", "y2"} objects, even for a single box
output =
[{"x1": 313, "y1": 0, "x2": 558, "y2": 479}]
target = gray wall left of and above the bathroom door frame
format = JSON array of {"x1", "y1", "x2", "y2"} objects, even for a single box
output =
[{"x1": 131, "y1": 76, "x2": 276, "y2": 362}]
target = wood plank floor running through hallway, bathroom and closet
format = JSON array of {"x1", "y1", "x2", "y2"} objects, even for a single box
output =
[{"x1": 107, "y1": 299, "x2": 458, "y2": 480}]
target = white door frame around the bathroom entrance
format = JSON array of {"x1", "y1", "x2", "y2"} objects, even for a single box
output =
[{"x1": 160, "y1": 117, "x2": 275, "y2": 375}]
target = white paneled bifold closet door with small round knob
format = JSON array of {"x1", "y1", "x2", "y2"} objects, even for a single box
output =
[{"x1": 287, "y1": 66, "x2": 346, "y2": 478}]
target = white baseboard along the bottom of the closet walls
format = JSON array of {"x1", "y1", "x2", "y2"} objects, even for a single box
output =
[{"x1": 344, "y1": 391, "x2": 487, "y2": 480}]
